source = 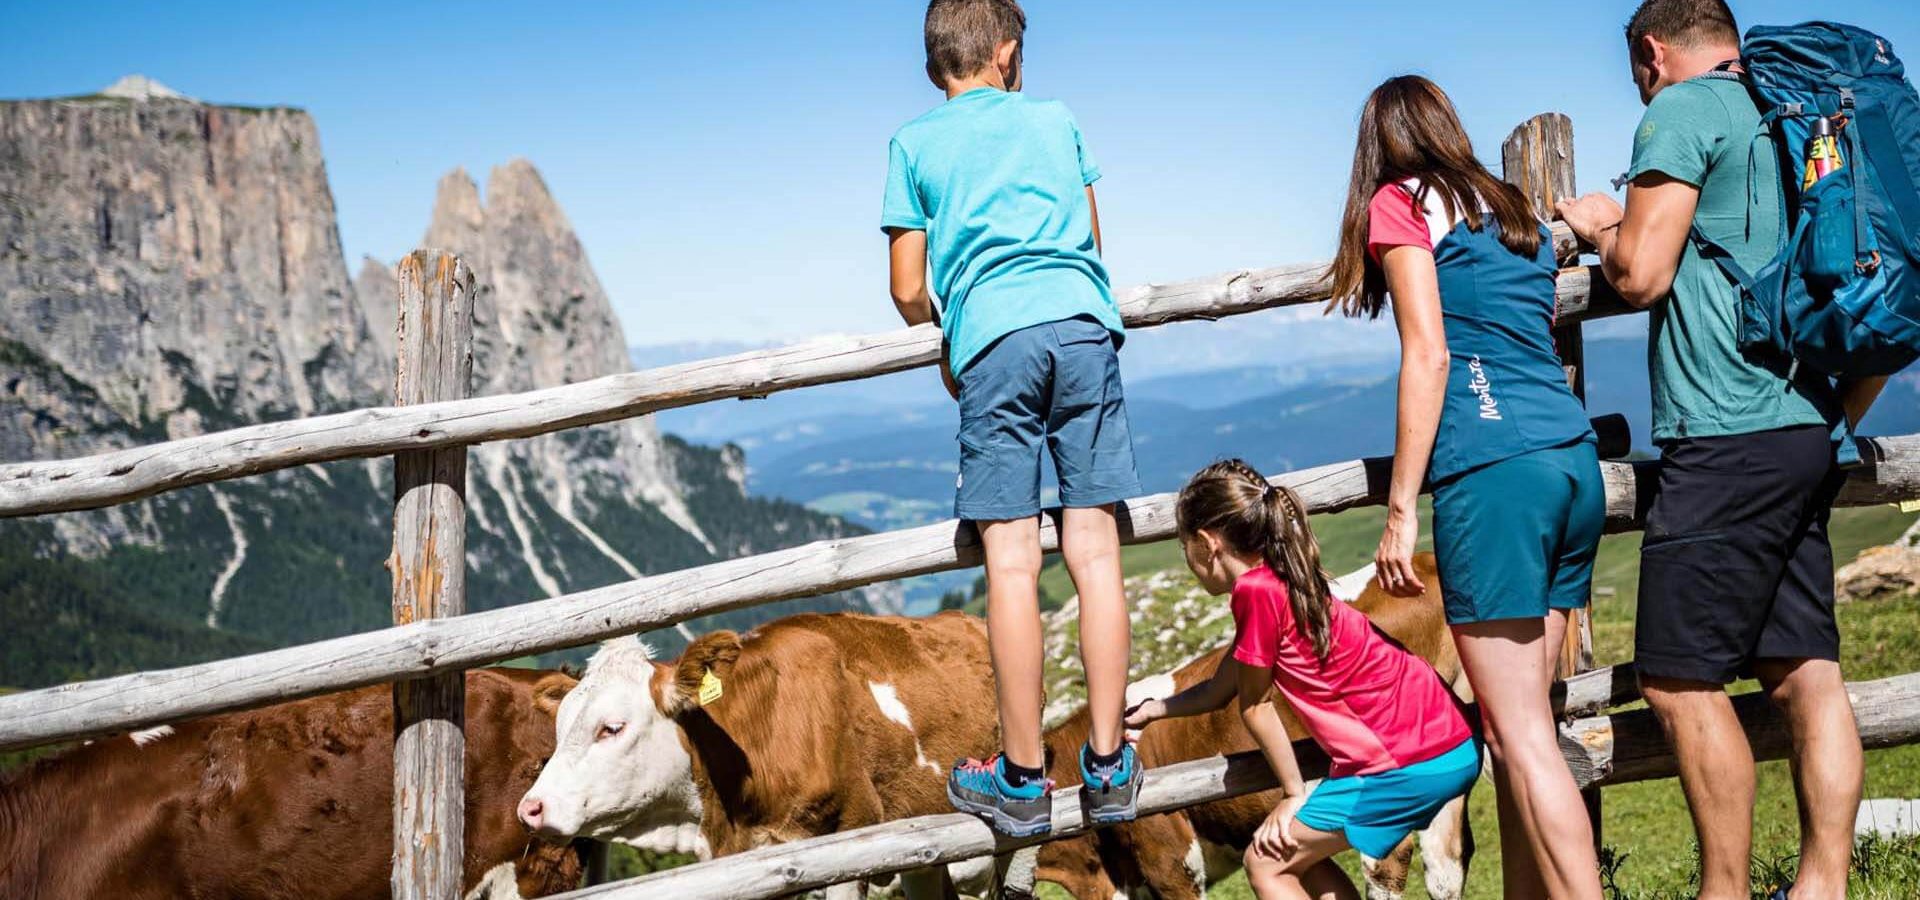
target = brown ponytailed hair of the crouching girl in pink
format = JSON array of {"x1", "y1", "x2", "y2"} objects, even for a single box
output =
[{"x1": 1175, "y1": 459, "x2": 1332, "y2": 662}]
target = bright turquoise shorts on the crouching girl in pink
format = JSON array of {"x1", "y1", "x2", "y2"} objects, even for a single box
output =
[{"x1": 1294, "y1": 737, "x2": 1480, "y2": 860}]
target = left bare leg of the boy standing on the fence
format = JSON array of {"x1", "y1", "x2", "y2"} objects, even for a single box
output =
[{"x1": 979, "y1": 518, "x2": 1046, "y2": 770}]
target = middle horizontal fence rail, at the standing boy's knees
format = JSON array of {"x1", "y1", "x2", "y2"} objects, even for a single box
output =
[{"x1": 0, "y1": 434, "x2": 1920, "y2": 750}]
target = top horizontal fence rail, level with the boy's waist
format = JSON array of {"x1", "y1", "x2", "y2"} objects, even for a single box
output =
[{"x1": 0, "y1": 225, "x2": 1628, "y2": 518}]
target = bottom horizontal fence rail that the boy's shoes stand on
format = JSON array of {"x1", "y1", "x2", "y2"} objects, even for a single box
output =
[{"x1": 541, "y1": 672, "x2": 1920, "y2": 900}]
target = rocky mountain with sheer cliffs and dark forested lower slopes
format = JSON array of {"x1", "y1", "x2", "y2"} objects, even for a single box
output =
[{"x1": 0, "y1": 79, "x2": 879, "y2": 687}]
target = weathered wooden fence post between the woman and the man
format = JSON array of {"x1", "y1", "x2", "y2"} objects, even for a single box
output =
[{"x1": 1500, "y1": 113, "x2": 1601, "y2": 850}]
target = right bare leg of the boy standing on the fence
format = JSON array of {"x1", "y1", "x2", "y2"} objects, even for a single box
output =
[{"x1": 1060, "y1": 507, "x2": 1133, "y2": 754}]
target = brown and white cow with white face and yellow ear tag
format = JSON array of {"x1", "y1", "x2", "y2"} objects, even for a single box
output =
[{"x1": 520, "y1": 612, "x2": 998, "y2": 898}]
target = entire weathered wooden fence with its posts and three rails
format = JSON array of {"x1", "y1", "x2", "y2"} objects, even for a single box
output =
[{"x1": 0, "y1": 113, "x2": 1920, "y2": 900}]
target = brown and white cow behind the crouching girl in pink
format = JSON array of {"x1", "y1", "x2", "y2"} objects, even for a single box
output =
[{"x1": 1037, "y1": 555, "x2": 1473, "y2": 900}]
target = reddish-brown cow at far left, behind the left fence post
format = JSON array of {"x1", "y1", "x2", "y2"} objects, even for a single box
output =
[{"x1": 0, "y1": 670, "x2": 582, "y2": 900}]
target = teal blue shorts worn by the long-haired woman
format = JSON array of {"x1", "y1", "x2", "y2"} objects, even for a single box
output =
[{"x1": 1434, "y1": 441, "x2": 1607, "y2": 626}]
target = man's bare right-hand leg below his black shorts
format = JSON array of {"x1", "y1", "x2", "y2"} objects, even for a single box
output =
[{"x1": 1755, "y1": 660, "x2": 1864, "y2": 900}]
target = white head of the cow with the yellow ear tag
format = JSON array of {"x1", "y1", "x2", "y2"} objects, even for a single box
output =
[{"x1": 518, "y1": 633, "x2": 739, "y2": 844}]
